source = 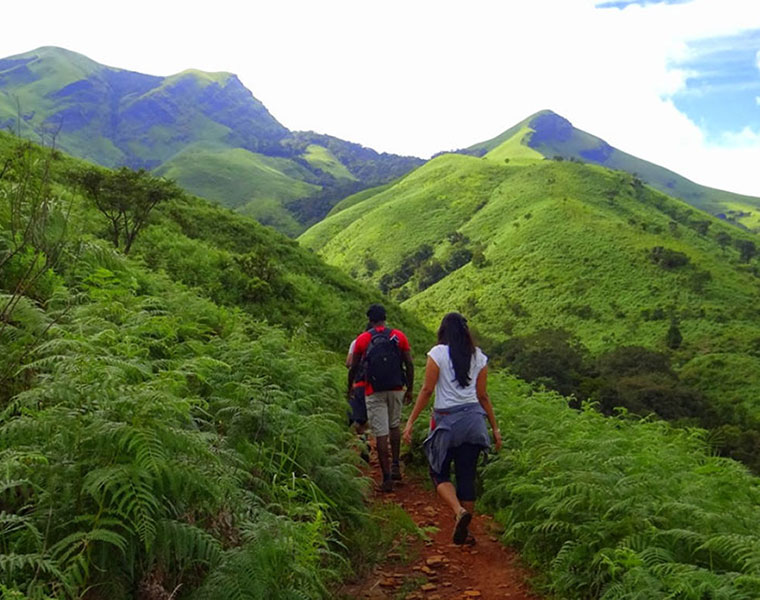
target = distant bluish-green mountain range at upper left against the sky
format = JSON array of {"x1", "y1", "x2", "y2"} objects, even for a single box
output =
[{"x1": 0, "y1": 47, "x2": 422, "y2": 235}]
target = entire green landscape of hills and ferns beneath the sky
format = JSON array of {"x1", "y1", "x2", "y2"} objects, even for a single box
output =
[{"x1": 0, "y1": 47, "x2": 760, "y2": 600}]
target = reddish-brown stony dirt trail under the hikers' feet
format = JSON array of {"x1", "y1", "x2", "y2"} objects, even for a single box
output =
[{"x1": 342, "y1": 458, "x2": 540, "y2": 600}]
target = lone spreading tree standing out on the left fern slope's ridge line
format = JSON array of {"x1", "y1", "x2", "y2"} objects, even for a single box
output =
[{"x1": 74, "y1": 167, "x2": 182, "y2": 254}]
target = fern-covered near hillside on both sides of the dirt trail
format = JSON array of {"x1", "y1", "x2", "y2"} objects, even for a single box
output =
[{"x1": 0, "y1": 129, "x2": 760, "y2": 600}]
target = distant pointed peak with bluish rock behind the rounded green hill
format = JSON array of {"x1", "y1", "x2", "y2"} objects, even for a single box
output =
[{"x1": 458, "y1": 110, "x2": 760, "y2": 231}]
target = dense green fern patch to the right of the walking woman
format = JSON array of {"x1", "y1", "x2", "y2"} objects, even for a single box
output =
[{"x1": 480, "y1": 377, "x2": 760, "y2": 600}]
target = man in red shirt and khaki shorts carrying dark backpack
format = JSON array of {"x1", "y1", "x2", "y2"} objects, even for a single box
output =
[{"x1": 348, "y1": 304, "x2": 414, "y2": 492}]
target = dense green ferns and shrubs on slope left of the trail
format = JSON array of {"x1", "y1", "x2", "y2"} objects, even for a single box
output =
[{"x1": 0, "y1": 136, "x2": 425, "y2": 599}]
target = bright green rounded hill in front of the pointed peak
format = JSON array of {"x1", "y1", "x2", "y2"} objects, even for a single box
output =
[{"x1": 300, "y1": 154, "x2": 760, "y2": 460}]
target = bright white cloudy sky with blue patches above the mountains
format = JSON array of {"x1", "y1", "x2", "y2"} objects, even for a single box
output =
[{"x1": 0, "y1": 0, "x2": 760, "y2": 196}]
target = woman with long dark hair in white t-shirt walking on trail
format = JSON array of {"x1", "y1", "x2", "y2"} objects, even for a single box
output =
[{"x1": 402, "y1": 312, "x2": 501, "y2": 544}]
